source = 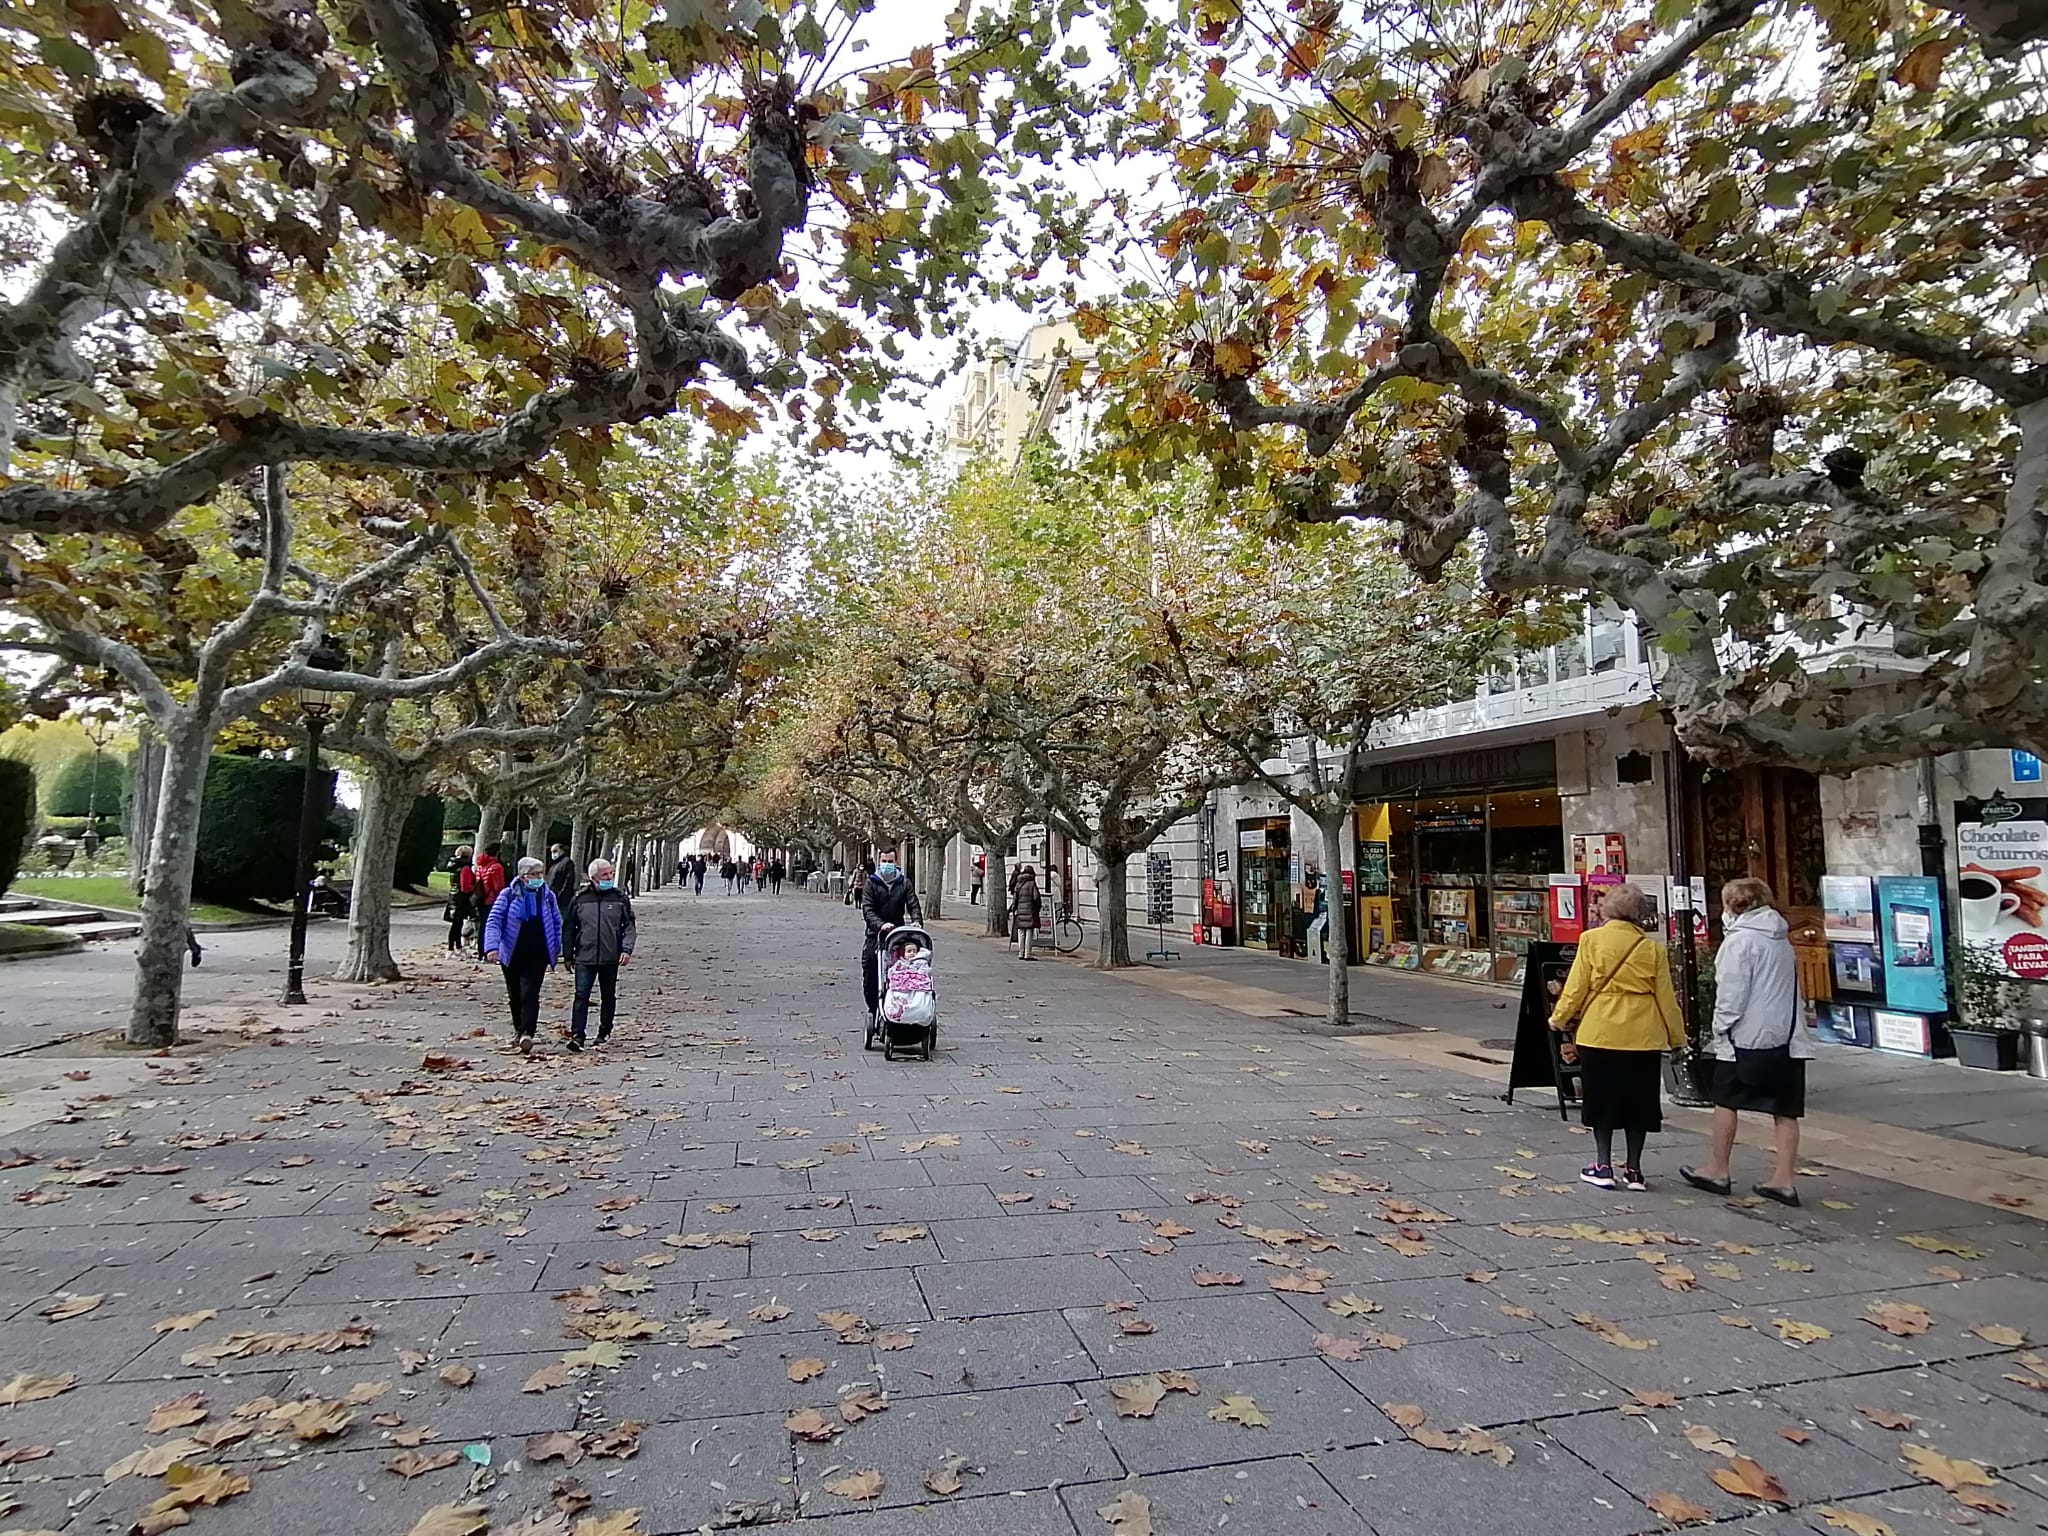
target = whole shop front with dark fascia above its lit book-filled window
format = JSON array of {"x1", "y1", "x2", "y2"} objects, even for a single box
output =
[{"x1": 1356, "y1": 741, "x2": 1567, "y2": 981}]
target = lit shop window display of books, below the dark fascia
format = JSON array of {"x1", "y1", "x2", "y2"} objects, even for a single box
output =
[{"x1": 1358, "y1": 788, "x2": 1565, "y2": 981}]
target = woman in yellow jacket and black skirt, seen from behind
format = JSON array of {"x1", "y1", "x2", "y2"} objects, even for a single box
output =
[{"x1": 1550, "y1": 885, "x2": 1686, "y2": 1190}]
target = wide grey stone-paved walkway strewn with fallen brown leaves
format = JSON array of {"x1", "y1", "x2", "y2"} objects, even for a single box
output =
[{"x1": 0, "y1": 893, "x2": 2048, "y2": 1536}]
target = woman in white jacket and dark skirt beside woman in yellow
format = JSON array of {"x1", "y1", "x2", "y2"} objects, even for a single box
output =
[{"x1": 1679, "y1": 881, "x2": 1815, "y2": 1206}]
